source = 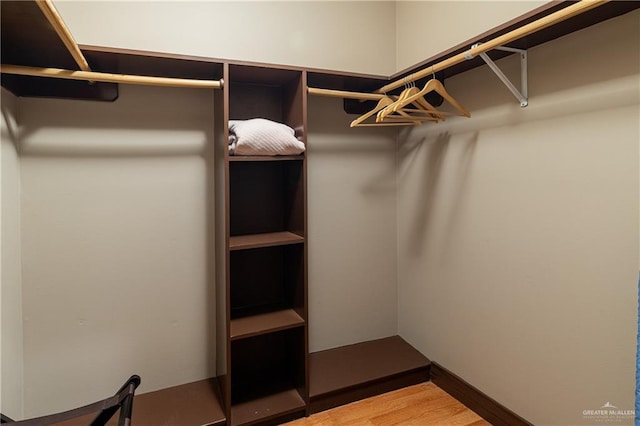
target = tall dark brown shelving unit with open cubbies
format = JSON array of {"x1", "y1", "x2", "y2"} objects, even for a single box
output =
[{"x1": 215, "y1": 64, "x2": 308, "y2": 425}]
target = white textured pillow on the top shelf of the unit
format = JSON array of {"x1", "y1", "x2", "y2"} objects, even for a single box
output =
[{"x1": 229, "y1": 118, "x2": 305, "y2": 155}]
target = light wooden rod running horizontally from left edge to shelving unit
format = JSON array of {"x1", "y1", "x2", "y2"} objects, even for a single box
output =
[{"x1": 0, "y1": 64, "x2": 223, "y2": 89}]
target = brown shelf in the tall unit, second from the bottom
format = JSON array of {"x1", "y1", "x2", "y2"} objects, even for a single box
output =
[{"x1": 230, "y1": 309, "x2": 305, "y2": 340}]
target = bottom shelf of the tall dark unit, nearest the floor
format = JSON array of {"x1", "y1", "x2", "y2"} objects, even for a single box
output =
[{"x1": 231, "y1": 389, "x2": 306, "y2": 425}]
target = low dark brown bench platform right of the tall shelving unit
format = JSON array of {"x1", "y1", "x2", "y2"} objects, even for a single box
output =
[{"x1": 309, "y1": 336, "x2": 431, "y2": 413}]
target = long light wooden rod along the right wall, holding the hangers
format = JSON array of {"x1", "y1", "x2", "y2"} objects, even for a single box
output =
[{"x1": 376, "y1": 0, "x2": 609, "y2": 93}]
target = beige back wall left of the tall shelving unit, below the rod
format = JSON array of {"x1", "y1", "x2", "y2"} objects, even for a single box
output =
[{"x1": 20, "y1": 85, "x2": 216, "y2": 417}]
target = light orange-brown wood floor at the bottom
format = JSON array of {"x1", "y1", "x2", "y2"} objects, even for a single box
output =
[{"x1": 287, "y1": 382, "x2": 489, "y2": 426}]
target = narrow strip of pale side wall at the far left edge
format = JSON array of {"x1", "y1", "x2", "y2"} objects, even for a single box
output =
[{"x1": 0, "y1": 89, "x2": 23, "y2": 419}]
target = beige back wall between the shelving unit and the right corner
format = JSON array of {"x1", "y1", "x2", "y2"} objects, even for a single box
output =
[{"x1": 307, "y1": 97, "x2": 397, "y2": 352}]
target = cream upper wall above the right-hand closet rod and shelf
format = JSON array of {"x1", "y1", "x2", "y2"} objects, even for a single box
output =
[{"x1": 395, "y1": 0, "x2": 547, "y2": 71}]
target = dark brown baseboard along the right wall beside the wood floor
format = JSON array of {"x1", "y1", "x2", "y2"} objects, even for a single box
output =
[{"x1": 431, "y1": 362, "x2": 533, "y2": 426}]
